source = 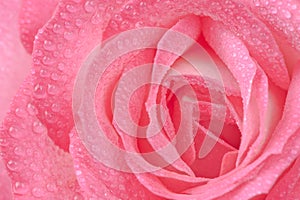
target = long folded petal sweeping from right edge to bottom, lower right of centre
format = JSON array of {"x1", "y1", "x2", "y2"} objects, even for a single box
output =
[{"x1": 182, "y1": 62, "x2": 300, "y2": 199}]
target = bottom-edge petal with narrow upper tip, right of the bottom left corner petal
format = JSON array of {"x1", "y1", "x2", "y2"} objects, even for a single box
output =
[{"x1": 70, "y1": 130, "x2": 160, "y2": 199}]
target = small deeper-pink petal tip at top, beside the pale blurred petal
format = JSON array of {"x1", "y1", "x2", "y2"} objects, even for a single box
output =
[{"x1": 20, "y1": 0, "x2": 58, "y2": 53}]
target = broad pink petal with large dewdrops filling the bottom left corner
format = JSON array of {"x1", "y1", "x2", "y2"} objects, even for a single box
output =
[{"x1": 0, "y1": 81, "x2": 81, "y2": 200}]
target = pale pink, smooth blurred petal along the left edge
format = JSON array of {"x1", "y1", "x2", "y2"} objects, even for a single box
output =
[{"x1": 0, "y1": 0, "x2": 31, "y2": 122}]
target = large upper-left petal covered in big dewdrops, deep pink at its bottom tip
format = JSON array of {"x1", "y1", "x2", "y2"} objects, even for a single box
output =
[{"x1": 29, "y1": 1, "x2": 129, "y2": 151}]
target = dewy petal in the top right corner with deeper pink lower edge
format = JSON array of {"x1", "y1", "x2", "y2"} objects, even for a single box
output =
[{"x1": 242, "y1": 0, "x2": 300, "y2": 72}]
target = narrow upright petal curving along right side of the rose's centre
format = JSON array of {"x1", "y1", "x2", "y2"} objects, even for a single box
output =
[{"x1": 204, "y1": 20, "x2": 258, "y2": 163}]
